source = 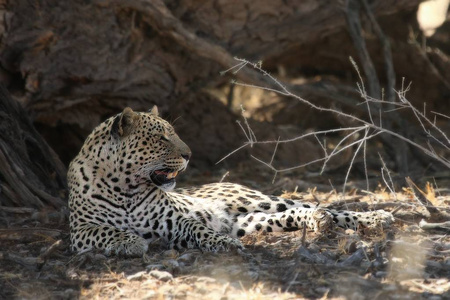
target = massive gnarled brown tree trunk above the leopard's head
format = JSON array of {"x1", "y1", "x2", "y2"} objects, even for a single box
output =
[{"x1": 0, "y1": 0, "x2": 426, "y2": 123}]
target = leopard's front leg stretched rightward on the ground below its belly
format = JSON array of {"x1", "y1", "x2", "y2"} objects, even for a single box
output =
[{"x1": 169, "y1": 217, "x2": 243, "y2": 252}]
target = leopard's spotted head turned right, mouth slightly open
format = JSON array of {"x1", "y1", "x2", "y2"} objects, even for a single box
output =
[{"x1": 109, "y1": 106, "x2": 191, "y2": 190}]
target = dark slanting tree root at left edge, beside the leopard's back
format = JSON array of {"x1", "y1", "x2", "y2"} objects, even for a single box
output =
[{"x1": 0, "y1": 85, "x2": 66, "y2": 208}]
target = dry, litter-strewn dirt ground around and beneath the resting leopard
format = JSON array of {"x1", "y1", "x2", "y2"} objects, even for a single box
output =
[{"x1": 0, "y1": 169, "x2": 450, "y2": 299}]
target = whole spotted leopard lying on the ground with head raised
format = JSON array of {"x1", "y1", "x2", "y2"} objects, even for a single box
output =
[{"x1": 67, "y1": 106, "x2": 394, "y2": 257}]
